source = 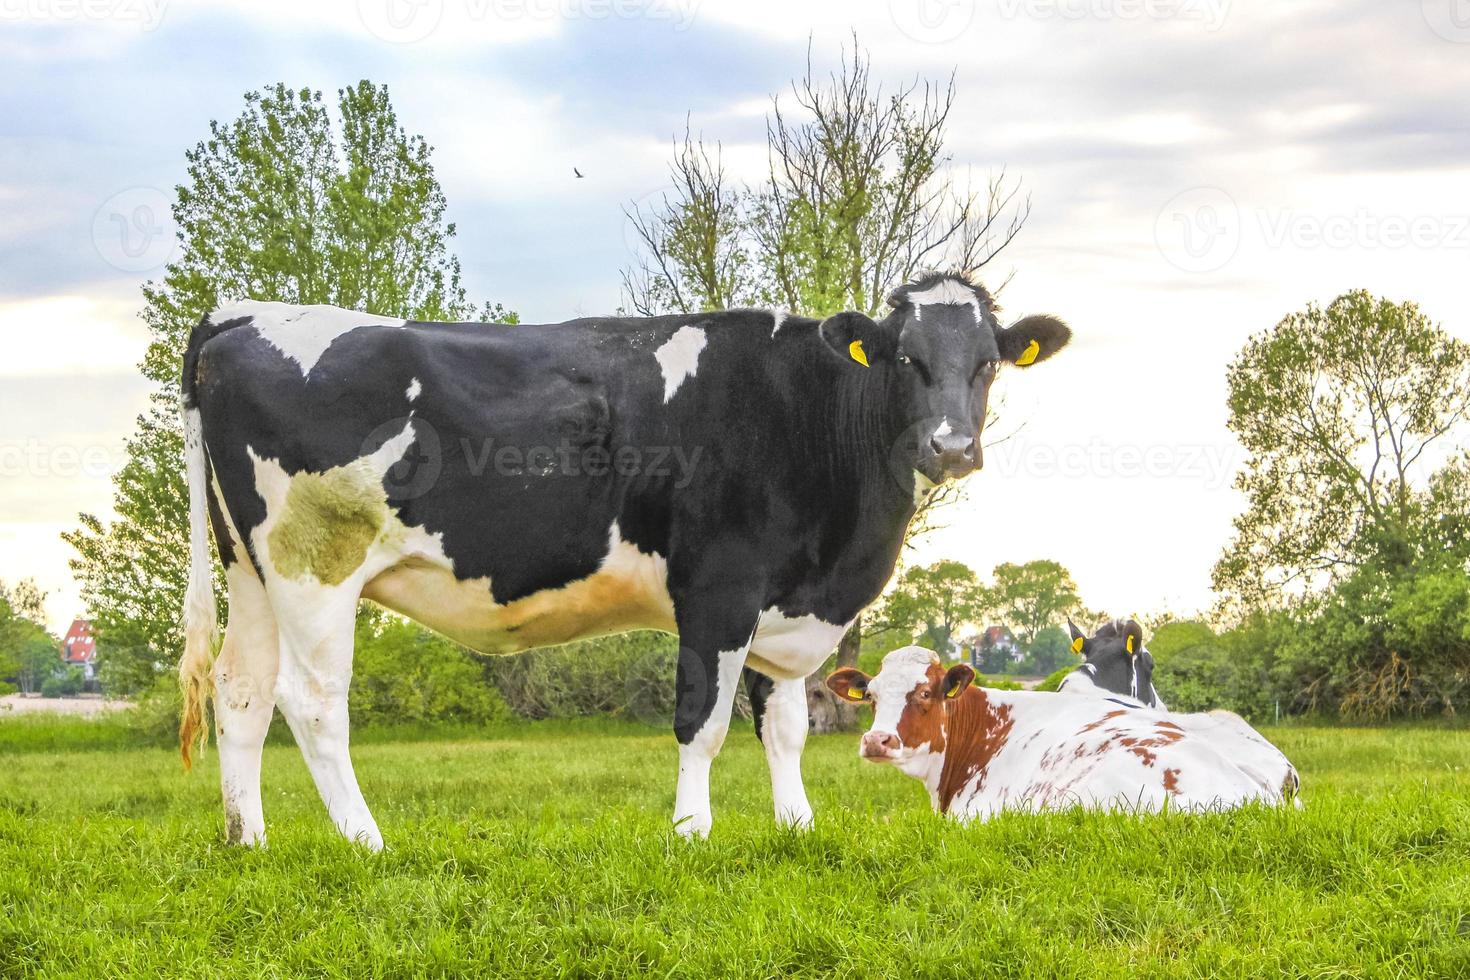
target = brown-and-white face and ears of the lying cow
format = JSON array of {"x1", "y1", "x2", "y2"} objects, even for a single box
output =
[{"x1": 826, "y1": 646, "x2": 975, "y2": 776}]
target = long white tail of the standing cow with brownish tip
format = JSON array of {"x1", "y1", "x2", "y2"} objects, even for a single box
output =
[{"x1": 179, "y1": 317, "x2": 219, "y2": 770}]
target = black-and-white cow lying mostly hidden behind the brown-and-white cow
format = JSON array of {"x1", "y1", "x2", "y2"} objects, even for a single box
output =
[{"x1": 1057, "y1": 620, "x2": 1301, "y2": 796}]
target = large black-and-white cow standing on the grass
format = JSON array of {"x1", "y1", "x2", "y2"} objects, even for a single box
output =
[{"x1": 179, "y1": 276, "x2": 1070, "y2": 848}]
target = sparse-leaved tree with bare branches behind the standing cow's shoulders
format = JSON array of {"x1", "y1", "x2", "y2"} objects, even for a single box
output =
[{"x1": 623, "y1": 38, "x2": 1030, "y2": 316}]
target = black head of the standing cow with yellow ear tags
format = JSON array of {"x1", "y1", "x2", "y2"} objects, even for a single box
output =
[{"x1": 822, "y1": 275, "x2": 1072, "y2": 483}]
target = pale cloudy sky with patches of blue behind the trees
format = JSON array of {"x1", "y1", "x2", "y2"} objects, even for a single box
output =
[{"x1": 0, "y1": 0, "x2": 1470, "y2": 624}]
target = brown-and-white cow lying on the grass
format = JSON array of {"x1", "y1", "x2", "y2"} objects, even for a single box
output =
[{"x1": 828, "y1": 646, "x2": 1295, "y2": 820}]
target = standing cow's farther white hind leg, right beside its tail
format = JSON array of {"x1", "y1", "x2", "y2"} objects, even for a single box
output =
[{"x1": 215, "y1": 563, "x2": 278, "y2": 845}]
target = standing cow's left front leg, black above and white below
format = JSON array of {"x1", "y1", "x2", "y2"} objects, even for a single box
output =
[{"x1": 673, "y1": 617, "x2": 756, "y2": 837}]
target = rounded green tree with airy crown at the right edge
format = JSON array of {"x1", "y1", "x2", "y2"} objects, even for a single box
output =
[{"x1": 1214, "y1": 291, "x2": 1470, "y2": 611}]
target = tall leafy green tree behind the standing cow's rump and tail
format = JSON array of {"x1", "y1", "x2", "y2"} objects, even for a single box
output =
[{"x1": 63, "y1": 81, "x2": 515, "y2": 692}]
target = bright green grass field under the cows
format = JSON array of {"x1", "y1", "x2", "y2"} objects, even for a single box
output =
[{"x1": 0, "y1": 720, "x2": 1470, "y2": 977}]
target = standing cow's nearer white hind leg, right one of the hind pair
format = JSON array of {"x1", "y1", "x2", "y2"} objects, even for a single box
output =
[{"x1": 272, "y1": 582, "x2": 382, "y2": 851}]
